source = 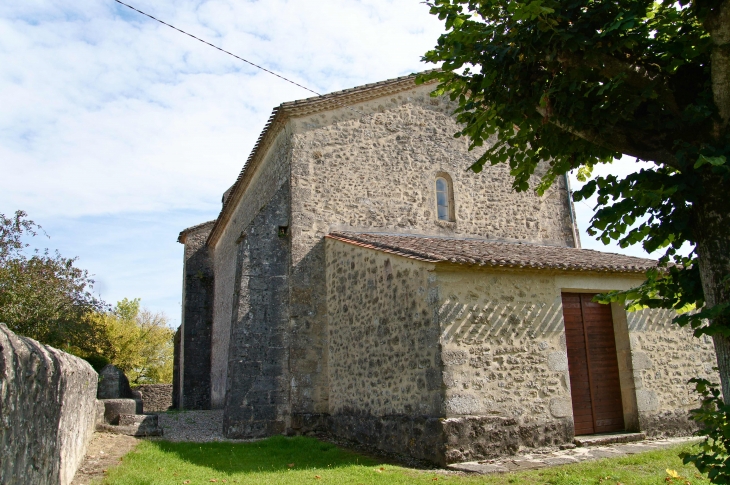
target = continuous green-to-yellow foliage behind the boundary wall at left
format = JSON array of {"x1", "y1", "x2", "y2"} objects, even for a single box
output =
[{"x1": 0, "y1": 211, "x2": 174, "y2": 384}]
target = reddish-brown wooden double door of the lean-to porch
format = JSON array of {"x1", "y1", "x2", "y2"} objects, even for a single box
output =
[{"x1": 562, "y1": 293, "x2": 624, "y2": 435}]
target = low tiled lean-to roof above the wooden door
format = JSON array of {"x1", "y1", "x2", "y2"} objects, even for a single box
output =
[{"x1": 327, "y1": 232, "x2": 657, "y2": 273}]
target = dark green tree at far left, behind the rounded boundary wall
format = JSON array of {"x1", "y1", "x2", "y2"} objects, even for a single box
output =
[{"x1": 0, "y1": 211, "x2": 105, "y2": 349}]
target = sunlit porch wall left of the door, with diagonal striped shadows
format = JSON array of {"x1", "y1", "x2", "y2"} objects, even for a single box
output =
[{"x1": 437, "y1": 268, "x2": 572, "y2": 432}]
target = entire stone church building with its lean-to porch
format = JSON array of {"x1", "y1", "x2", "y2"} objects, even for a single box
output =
[{"x1": 174, "y1": 76, "x2": 715, "y2": 464}]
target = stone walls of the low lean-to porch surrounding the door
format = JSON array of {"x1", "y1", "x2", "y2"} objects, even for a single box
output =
[{"x1": 326, "y1": 239, "x2": 717, "y2": 463}]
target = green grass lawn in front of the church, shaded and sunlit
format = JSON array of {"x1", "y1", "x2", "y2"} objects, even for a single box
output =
[{"x1": 96, "y1": 436, "x2": 709, "y2": 485}]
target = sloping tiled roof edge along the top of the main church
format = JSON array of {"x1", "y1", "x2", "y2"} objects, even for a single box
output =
[{"x1": 207, "y1": 74, "x2": 437, "y2": 245}]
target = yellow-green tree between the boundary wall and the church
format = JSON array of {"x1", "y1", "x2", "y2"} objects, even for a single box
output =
[{"x1": 89, "y1": 298, "x2": 175, "y2": 385}]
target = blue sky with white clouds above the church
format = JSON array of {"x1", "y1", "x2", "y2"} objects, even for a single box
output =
[{"x1": 0, "y1": 0, "x2": 660, "y2": 326}]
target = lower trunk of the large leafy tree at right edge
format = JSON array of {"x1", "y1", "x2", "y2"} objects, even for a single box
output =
[{"x1": 695, "y1": 170, "x2": 730, "y2": 403}]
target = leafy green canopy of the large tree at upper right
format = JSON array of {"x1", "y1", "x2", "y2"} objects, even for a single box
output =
[{"x1": 419, "y1": 0, "x2": 730, "y2": 386}]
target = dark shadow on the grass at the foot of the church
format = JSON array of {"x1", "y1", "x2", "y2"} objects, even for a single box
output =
[{"x1": 150, "y1": 436, "x2": 377, "y2": 473}]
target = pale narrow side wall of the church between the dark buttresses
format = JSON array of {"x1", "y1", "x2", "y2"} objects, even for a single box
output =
[{"x1": 211, "y1": 127, "x2": 291, "y2": 409}]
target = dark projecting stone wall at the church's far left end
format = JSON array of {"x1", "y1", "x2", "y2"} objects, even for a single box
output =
[{"x1": 179, "y1": 224, "x2": 215, "y2": 409}]
